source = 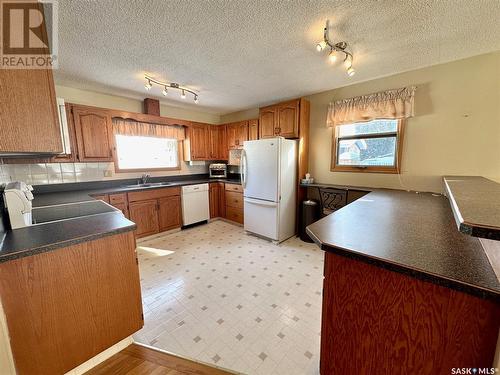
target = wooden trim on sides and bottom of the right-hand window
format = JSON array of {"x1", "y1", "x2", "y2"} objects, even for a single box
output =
[{"x1": 330, "y1": 120, "x2": 406, "y2": 174}]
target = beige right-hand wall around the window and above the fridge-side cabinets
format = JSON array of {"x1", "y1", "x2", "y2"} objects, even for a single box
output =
[{"x1": 221, "y1": 52, "x2": 500, "y2": 192}]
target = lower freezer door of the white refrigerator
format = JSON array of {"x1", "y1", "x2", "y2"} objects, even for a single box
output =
[{"x1": 243, "y1": 198, "x2": 279, "y2": 241}]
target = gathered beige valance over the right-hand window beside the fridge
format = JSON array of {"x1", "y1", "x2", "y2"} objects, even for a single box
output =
[{"x1": 326, "y1": 86, "x2": 417, "y2": 127}]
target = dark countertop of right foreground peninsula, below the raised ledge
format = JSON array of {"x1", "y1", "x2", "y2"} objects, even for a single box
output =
[{"x1": 307, "y1": 189, "x2": 500, "y2": 300}]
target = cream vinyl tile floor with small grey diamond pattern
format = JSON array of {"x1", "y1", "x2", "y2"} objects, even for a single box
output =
[{"x1": 134, "y1": 220, "x2": 324, "y2": 375}]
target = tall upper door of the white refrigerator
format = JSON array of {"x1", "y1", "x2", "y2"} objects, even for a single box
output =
[{"x1": 241, "y1": 138, "x2": 280, "y2": 202}]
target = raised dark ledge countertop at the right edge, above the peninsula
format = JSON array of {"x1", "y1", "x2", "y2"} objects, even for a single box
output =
[{"x1": 443, "y1": 176, "x2": 500, "y2": 240}]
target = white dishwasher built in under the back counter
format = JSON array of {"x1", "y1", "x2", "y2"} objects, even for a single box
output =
[{"x1": 182, "y1": 184, "x2": 210, "y2": 226}]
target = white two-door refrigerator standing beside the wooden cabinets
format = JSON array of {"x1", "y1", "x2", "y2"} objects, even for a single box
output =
[{"x1": 240, "y1": 137, "x2": 297, "y2": 242}]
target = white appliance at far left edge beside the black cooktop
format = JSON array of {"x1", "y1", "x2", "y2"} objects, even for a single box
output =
[{"x1": 3, "y1": 181, "x2": 33, "y2": 229}]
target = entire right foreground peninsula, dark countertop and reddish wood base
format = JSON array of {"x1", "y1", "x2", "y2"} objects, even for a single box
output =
[{"x1": 307, "y1": 189, "x2": 500, "y2": 375}]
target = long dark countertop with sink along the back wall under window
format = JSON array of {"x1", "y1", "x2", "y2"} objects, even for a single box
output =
[{"x1": 33, "y1": 178, "x2": 241, "y2": 207}]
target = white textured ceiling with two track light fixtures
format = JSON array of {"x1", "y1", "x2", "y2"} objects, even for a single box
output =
[{"x1": 55, "y1": 0, "x2": 500, "y2": 114}]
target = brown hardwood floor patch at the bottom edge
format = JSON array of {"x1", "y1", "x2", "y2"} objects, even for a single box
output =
[{"x1": 86, "y1": 344, "x2": 232, "y2": 375}]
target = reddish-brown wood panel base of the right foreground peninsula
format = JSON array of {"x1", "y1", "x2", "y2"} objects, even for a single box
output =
[{"x1": 320, "y1": 252, "x2": 500, "y2": 375}]
